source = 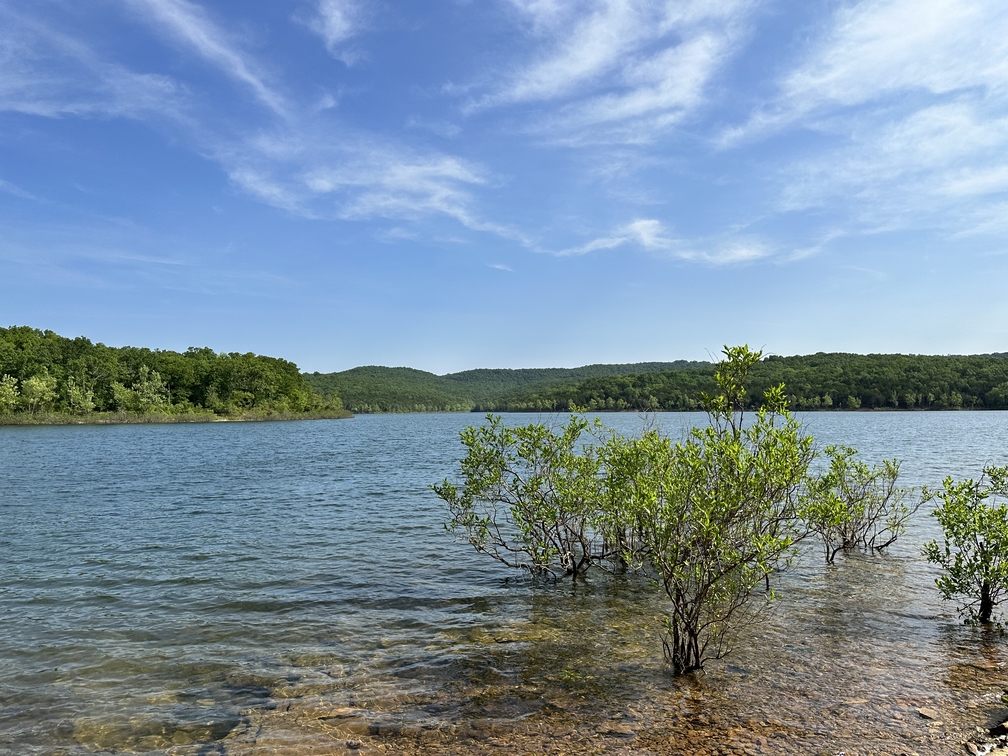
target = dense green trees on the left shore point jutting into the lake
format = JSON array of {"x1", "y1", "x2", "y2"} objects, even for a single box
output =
[{"x1": 0, "y1": 327, "x2": 340, "y2": 415}]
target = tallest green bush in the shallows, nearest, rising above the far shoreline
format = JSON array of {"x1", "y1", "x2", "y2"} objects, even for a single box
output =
[{"x1": 621, "y1": 347, "x2": 814, "y2": 673}]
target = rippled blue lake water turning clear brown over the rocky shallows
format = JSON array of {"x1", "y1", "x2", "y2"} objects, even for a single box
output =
[{"x1": 0, "y1": 412, "x2": 1008, "y2": 754}]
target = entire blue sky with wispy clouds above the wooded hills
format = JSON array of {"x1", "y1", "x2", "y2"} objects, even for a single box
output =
[{"x1": 0, "y1": 0, "x2": 1008, "y2": 373}]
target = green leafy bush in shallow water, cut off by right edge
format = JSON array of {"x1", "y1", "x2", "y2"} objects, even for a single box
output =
[{"x1": 923, "y1": 467, "x2": 1008, "y2": 625}]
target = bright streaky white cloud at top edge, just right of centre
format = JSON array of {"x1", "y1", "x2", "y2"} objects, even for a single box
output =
[{"x1": 465, "y1": 0, "x2": 750, "y2": 143}]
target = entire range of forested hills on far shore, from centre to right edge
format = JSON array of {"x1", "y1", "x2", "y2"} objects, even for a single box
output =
[{"x1": 305, "y1": 353, "x2": 1008, "y2": 412}]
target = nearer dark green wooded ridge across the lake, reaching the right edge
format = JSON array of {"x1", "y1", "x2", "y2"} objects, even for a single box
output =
[{"x1": 495, "y1": 354, "x2": 1008, "y2": 411}]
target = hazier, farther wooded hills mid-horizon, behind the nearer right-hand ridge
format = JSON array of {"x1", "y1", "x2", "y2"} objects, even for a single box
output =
[{"x1": 304, "y1": 360, "x2": 711, "y2": 412}]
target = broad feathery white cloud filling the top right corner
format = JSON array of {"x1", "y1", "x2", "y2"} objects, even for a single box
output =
[{"x1": 719, "y1": 0, "x2": 1008, "y2": 242}]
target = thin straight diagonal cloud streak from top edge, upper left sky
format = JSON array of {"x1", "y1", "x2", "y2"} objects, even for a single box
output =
[{"x1": 128, "y1": 0, "x2": 287, "y2": 116}]
